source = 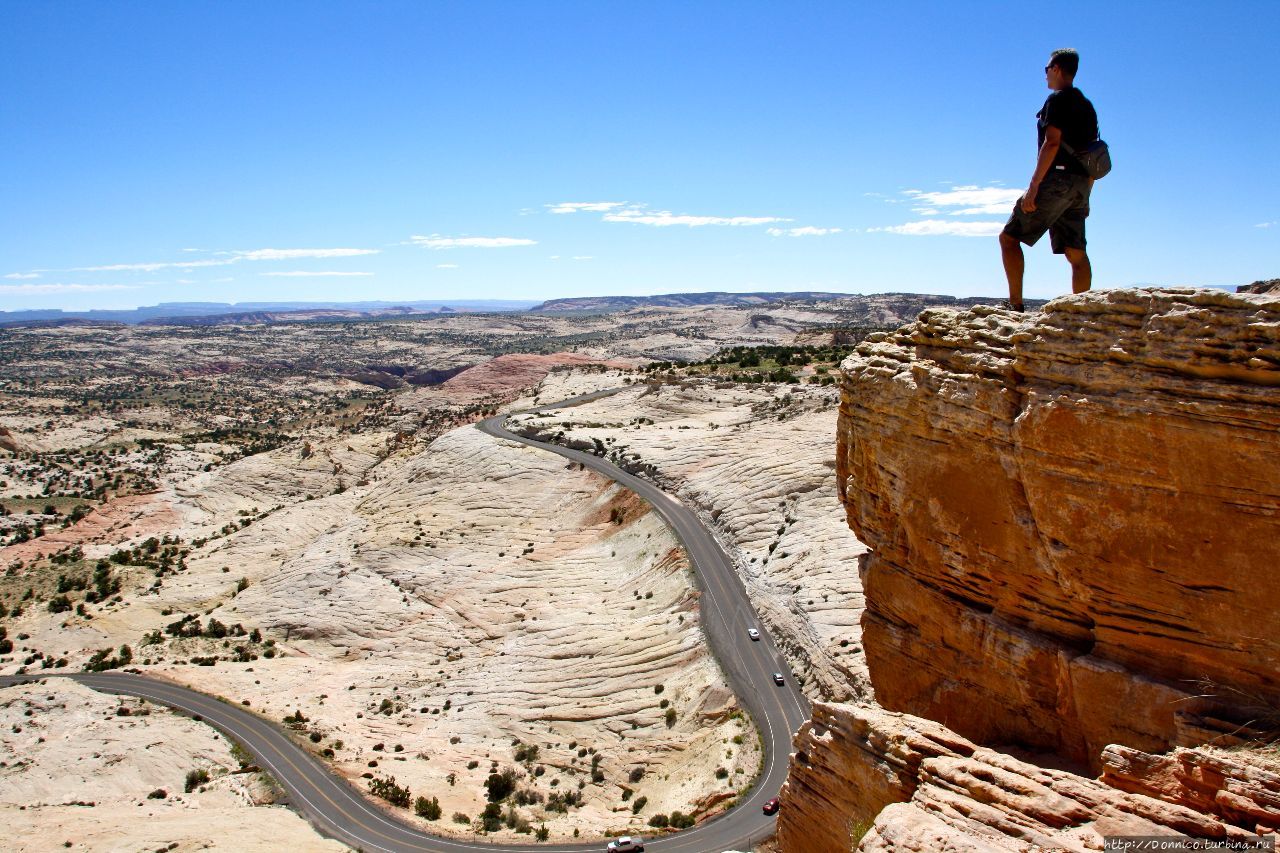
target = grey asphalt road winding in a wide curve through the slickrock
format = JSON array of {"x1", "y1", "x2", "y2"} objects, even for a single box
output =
[{"x1": 0, "y1": 389, "x2": 809, "y2": 853}]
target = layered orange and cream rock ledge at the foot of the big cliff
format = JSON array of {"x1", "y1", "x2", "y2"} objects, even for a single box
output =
[{"x1": 778, "y1": 703, "x2": 1280, "y2": 853}]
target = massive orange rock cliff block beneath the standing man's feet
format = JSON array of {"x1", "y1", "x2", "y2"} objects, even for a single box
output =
[{"x1": 837, "y1": 289, "x2": 1280, "y2": 768}]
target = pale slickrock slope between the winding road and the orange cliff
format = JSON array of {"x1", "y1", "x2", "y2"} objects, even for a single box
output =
[{"x1": 511, "y1": 374, "x2": 868, "y2": 699}]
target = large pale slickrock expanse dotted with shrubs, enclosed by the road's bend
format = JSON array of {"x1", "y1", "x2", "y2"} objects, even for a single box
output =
[{"x1": 9, "y1": 427, "x2": 759, "y2": 835}]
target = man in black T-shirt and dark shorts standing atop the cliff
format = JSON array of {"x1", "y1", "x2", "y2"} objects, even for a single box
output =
[{"x1": 1000, "y1": 50, "x2": 1098, "y2": 311}]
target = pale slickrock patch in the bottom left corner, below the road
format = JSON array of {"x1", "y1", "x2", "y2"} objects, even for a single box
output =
[{"x1": 0, "y1": 679, "x2": 347, "y2": 853}]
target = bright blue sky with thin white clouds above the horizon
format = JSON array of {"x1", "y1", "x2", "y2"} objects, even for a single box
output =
[{"x1": 0, "y1": 0, "x2": 1280, "y2": 310}]
